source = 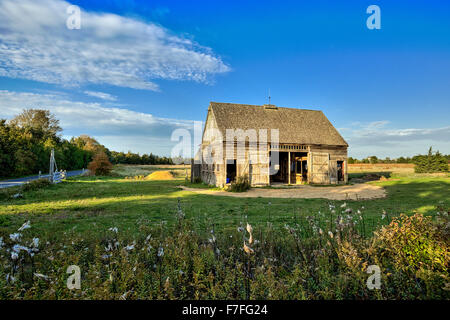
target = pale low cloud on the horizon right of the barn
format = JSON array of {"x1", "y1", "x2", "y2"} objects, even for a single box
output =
[{"x1": 339, "y1": 121, "x2": 450, "y2": 158}]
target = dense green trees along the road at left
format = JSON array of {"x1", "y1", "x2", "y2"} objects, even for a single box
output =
[{"x1": 0, "y1": 109, "x2": 172, "y2": 177}]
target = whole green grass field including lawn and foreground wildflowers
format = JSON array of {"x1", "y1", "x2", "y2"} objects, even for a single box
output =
[{"x1": 0, "y1": 166, "x2": 450, "y2": 300}]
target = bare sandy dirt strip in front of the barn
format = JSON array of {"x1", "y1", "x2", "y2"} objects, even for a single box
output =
[{"x1": 179, "y1": 183, "x2": 386, "y2": 200}]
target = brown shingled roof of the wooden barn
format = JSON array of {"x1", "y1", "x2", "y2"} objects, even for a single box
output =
[{"x1": 210, "y1": 102, "x2": 348, "y2": 147}]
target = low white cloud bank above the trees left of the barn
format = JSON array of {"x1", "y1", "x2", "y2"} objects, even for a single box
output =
[{"x1": 0, "y1": 90, "x2": 194, "y2": 155}]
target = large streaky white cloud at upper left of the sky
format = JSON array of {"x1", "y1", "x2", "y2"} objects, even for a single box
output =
[{"x1": 0, "y1": 0, "x2": 230, "y2": 90}]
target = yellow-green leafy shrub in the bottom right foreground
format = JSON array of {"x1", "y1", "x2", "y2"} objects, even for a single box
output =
[{"x1": 368, "y1": 214, "x2": 450, "y2": 299}]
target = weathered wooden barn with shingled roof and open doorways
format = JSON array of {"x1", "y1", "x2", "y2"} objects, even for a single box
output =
[{"x1": 191, "y1": 102, "x2": 348, "y2": 186}]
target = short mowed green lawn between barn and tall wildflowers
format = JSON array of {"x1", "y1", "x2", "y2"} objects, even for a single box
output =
[{"x1": 0, "y1": 170, "x2": 450, "y2": 238}]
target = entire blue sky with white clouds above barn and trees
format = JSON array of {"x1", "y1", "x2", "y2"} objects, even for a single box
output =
[{"x1": 0, "y1": 0, "x2": 450, "y2": 158}]
